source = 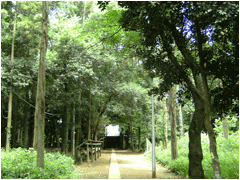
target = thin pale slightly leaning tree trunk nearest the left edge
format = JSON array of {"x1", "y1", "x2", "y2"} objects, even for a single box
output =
[{"x1": 6, "y1": 3, "x2": 17, "y2": 152}]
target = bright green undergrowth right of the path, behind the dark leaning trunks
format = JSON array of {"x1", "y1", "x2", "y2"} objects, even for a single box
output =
[{"x1": 148, "y1": 132, "x2": 239, "y2": 179}]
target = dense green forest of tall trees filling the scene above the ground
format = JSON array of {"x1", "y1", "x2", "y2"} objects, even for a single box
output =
[{"x1": 1, "y1": 1, "x2": 239, "y2": 178}]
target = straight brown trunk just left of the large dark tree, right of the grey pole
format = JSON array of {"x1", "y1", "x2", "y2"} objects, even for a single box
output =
[{"x1": 169, "y1": 85, "x2": 178, "y2": 160}]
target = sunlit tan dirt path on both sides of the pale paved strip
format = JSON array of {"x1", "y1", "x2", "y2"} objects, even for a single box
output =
[{"x1": 76, "y1": 150, "x2": 183, "y2": 179}]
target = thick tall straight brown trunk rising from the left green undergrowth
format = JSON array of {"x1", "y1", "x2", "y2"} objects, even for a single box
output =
[{"x1": 36, "y1": 1, "x2": 48, "y2": 168}]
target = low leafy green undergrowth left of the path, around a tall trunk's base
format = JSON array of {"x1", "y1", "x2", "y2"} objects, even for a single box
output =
[{"x1": 1, "y1": 148, "x2": 74, "y2": 179}]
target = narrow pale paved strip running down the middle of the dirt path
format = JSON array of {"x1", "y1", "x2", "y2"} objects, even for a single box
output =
[{"x1": 108, "y1": 149, "x2": 121, "y2": 179}]
